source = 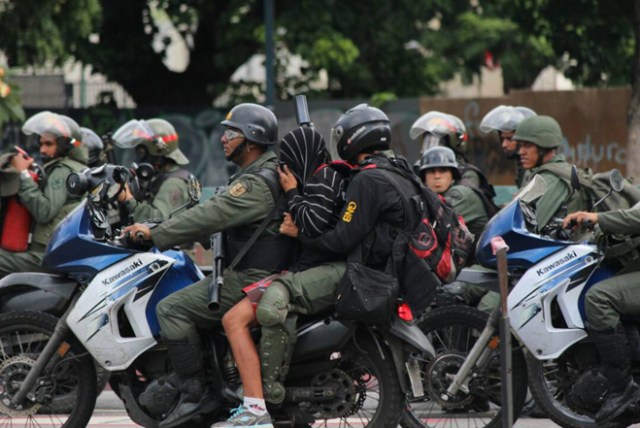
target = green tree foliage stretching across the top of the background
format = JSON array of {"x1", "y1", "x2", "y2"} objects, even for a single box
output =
[{"x1": 0, "y1": 0, "x2": 635, "y2": 106}]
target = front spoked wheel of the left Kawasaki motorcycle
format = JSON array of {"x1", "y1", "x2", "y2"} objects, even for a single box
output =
[{"x1": 0, "y1": 312, "x2": 96, "y2": 428}]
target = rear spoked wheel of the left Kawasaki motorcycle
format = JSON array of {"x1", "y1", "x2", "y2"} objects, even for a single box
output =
[{"x1": 303, "y1": 338, "x2": 403, "y2": 428}]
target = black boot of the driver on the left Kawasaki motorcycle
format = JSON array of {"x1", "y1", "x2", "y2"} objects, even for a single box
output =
[{"x1": 160, "y1": 339, "x2": 217, "y2": 428}]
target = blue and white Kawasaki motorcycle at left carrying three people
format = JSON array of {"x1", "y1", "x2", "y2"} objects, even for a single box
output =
[{"x1": 0, "y1": 165, "x2": 433, "y2": 428}]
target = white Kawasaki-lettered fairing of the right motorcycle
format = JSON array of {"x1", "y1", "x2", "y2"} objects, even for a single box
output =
[{"x1": 507, "y1": 244, "x2": 599, "y2": 360}]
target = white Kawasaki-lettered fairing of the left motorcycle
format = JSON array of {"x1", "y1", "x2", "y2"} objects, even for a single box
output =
[{"x1": 67, "y1": 253, "x2": 175, "y2": 371}]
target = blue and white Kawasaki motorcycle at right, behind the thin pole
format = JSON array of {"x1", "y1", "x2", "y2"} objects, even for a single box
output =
[{"x1": 402, "y1": 169, "x2": 638, "y2": 428}]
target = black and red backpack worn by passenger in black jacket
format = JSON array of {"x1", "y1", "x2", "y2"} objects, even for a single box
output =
[{"x1": 378, "y1": 159, "x2": 473, "y2": 313}]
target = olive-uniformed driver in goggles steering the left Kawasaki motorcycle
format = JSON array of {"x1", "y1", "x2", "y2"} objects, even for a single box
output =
[{"x1": 123, "y1": 104, "x2": 295, "y2": 427}]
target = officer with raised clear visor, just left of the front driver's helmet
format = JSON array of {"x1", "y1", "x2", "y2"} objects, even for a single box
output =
[{"x1": 113, "y1": 119, "x2": 191, "y2": 222}]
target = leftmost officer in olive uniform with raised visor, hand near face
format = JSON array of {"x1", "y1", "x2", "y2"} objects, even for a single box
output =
[{"x1": 0, "y1": 111, "x2": 88, "y2": 277}]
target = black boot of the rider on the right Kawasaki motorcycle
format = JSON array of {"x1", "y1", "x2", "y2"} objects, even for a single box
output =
[{"x1": 591, "y1": 329, "x2": 640, "y2": 423}]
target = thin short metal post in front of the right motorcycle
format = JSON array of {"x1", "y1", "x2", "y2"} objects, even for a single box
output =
[{"x1": 491, "y1": 236, "x2": 513, "y2": 427}]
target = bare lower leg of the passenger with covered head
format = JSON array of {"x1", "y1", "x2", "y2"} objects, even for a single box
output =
[{"x1": 222, "y1": 297, "x2": 264, "y2": 399}]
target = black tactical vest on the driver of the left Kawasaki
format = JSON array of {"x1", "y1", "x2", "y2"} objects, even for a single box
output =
[{"x1": 225, "y1": 168, "x2": 297, "y2": 273}]
